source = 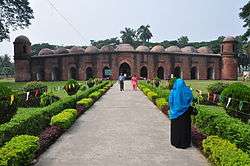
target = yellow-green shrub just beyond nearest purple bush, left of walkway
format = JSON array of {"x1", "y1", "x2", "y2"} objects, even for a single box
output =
[{"x1": 50, "y1": 109, "x2": 77, "y2": 129}]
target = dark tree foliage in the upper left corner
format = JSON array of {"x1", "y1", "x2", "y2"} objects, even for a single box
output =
[{"x1": 0, "y1": 0, "x2": 34, "y2": 42}]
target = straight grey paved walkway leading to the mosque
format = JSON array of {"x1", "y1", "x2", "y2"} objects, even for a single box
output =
[{"x1": 37, "y1": 82, "x2": 208, "y2": 166}]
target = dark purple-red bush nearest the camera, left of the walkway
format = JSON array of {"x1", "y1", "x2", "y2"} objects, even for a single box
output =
[{"x1": 36, "y1": 126, "x2": 63, "y2": 156}]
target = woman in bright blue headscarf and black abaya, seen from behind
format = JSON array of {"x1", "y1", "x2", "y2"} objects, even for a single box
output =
[{"x1": 169, "y1": 78, "x2": 193, "y2": 148}]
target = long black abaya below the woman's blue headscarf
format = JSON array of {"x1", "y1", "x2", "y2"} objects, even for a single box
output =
[{"x1": 171, "y1": 111, "x2": 191, "y2": 149}]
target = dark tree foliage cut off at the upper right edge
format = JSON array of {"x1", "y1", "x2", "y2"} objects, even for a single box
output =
[{"x1": 239, "y1": 1, "x2": 250, "y2": 40}]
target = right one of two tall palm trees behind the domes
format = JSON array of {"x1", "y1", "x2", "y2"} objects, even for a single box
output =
[{"x1": 137, "y1": 25, "x2": 153, "y2": 45}]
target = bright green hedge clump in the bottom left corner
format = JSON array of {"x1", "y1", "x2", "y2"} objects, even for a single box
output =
[{"x1": 0, "y1": 135, "x2": 39, "y2": 166}]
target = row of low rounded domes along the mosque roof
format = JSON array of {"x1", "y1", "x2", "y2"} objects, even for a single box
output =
[{"x1": 38, "y1": 44, "x2": 213, "y2": 55}]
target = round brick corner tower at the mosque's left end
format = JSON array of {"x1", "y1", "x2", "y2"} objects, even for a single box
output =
[{"x1": 13, "y1": 36, "x2": 31, "y2": 81}]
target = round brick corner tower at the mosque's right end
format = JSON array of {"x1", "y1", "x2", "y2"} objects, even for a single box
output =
[{"x1": 221, "y1": 36, "x2": 238, "y2": 80}]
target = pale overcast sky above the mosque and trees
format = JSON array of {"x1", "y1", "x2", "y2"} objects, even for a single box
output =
[{"x1": 0, "y1": 0, "x2": 248, "y2": 59}]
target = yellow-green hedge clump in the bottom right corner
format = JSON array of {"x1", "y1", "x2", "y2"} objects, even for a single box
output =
[{"x1": 202, "y1": 136, "x2": 250, "y2": 166}]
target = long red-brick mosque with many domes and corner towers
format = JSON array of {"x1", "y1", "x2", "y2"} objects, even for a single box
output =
[{"x1": 14, "y1": 36, "x2": 238, "y2": 81}]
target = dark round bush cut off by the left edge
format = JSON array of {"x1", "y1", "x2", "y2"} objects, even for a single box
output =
[{"x1": 0, "y1": 85, "x2": 17, "y2": 124}]
